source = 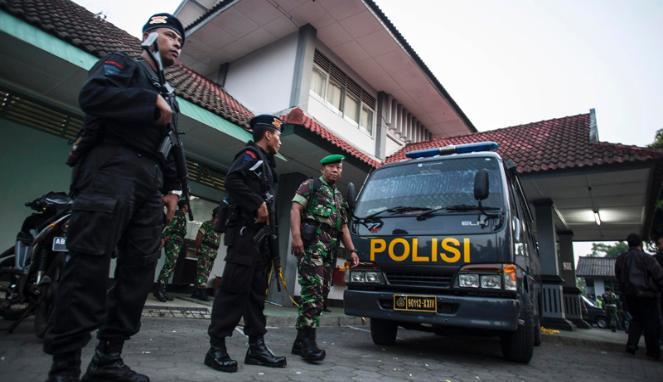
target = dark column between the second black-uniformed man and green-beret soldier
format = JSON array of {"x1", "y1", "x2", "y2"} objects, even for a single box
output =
[{"x1": 267, "y1": 173, "x2": 308, "y2": 306}]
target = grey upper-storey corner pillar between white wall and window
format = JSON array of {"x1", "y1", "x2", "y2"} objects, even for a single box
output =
[{"x1": 290, "y1": 24, "x2": 317, "y2": 110}]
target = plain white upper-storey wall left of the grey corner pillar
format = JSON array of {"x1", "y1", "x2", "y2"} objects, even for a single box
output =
[{"x1": 224, "y1": 33, "x2": 297, "y2": 114}]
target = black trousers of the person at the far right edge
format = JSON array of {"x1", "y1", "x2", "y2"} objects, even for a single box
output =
[{"x1": 626, "y1": 295, "x2": 661, "y2": 358}]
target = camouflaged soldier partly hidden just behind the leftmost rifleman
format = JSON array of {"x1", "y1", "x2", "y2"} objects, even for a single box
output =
[{"x1": 154, "y1": 200, "x2": 189, "y2": 302}]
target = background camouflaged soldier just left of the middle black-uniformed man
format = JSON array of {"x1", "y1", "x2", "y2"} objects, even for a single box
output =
[{"x1": 191, "y1": 207, "x2": 221, "y2": 301}]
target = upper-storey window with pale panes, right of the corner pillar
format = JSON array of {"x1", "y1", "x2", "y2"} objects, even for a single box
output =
[{"x1": 311, "y1": 50, "x2": 376, "y2": 135}]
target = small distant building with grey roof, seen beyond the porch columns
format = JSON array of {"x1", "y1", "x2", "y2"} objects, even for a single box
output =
[{"x1": 576, "y1": 256, "x2": 619, "y2": 298}]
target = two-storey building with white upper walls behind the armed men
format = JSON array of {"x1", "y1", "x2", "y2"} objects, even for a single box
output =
[{"x1": 0, "y1": 0, "x2": 476, "y2": 302}]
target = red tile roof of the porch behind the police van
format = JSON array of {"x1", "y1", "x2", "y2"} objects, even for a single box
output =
[{"x1": 386, "y1": 114, "x2": 663, "y2": 173}]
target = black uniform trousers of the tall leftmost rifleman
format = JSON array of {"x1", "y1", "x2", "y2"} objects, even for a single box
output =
[{"x1": 44, "y1": 145, "x2": 163, "y2": 354}]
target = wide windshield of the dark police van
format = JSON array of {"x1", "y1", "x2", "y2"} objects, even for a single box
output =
[{"x1": 355, "y1": 157, "x2": 503, "y2": 218}]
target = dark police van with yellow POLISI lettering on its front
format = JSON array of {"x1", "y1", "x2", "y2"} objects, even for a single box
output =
[{"x1": 344, "y1": 142, "x2": 541, "y2": 363}]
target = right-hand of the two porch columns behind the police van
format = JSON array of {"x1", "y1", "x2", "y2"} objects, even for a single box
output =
[{"x1": 557, "y1": 231, "x2": 591, "y2": 329}]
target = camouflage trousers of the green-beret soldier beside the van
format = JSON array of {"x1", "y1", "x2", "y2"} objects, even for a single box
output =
[{"x1": 296, "y1": 241, "x2": 331, "y2": 328}]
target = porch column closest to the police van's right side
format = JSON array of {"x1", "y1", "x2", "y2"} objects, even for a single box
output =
[{"x1": 534, "y1": 199, "x2": 575, "y2": 330}]
